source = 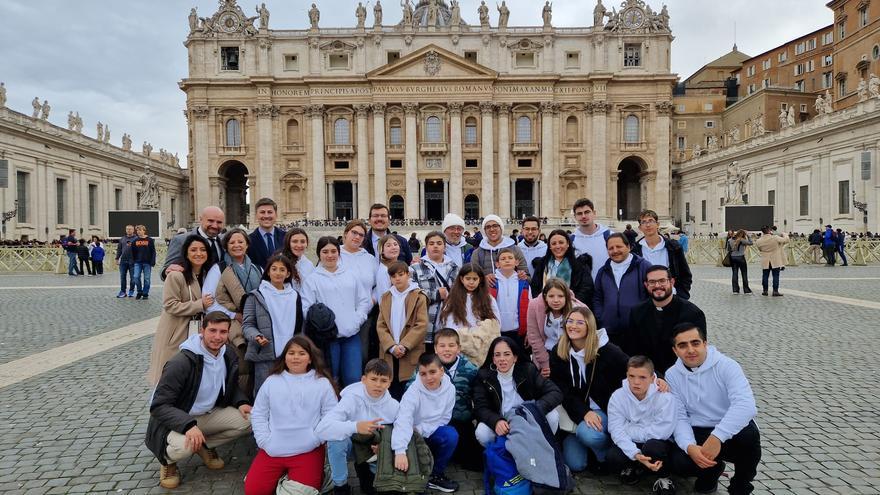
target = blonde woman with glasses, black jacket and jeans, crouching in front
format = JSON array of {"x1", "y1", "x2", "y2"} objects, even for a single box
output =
[{"x1": 550, "y1": 307, "x2": 629, "y2": 471}]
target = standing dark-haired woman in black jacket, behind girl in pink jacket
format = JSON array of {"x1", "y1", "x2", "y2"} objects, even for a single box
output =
[{"x1": 531, "y1": 229, "x2": 594, "y2": 305}]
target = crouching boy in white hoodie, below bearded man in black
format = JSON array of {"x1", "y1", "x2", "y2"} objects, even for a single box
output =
[{"x1": 606, "y1": 356, "x2": 678, "y2": 495}]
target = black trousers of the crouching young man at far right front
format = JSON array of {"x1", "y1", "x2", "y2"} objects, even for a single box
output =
[{"x1": 672, "y1": 421, "x2": 761, "y2": 495}]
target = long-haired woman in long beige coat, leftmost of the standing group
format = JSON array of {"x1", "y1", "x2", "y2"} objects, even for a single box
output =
[{"x1": 148, "y1": 234, "x2": 214, "y2": 385}]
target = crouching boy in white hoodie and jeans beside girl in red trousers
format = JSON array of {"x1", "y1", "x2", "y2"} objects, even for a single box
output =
[{"x1": 315, "y1": 359, "x2": 400, "y2": 494}]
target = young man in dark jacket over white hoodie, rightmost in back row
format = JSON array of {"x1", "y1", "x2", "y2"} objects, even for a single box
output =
[{"x1": 630, "y1": 210, "x2": 694, "y2": 298}]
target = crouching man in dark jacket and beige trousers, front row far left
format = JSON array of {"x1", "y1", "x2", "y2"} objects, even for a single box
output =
[{"x1": 144, "y1": 311, "x2": 251, "y2": 489}]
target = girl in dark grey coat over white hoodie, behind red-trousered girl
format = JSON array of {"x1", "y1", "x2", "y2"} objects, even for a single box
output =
[{"x1": 242, "y1": 254, "x2": 303, "y2": 395}]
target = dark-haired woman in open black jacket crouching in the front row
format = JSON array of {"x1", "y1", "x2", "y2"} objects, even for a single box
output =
[{"x1": 473, "y1": 336, "x2": 562, "y2": 447}]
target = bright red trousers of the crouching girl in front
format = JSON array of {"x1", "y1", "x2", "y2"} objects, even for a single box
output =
[{"x1": 244, "y1": 445, "x2": 324, "y2": 495}]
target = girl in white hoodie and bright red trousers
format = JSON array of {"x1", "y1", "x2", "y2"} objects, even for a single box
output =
[{"x1": 244, "y1": 335, "x2": 337, "y2": 495}]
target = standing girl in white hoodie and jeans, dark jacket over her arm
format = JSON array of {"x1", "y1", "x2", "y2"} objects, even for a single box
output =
[{"x1": 302, "y1": 236, "x2": 373, "y2": 387}]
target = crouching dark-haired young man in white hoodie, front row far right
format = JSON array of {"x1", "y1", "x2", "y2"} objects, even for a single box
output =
[{"x1": 666, "y1": 323, "x2": 761, "y2": 495}]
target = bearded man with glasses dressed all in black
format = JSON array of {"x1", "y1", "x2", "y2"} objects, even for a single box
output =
[{"x1": 622, "y1": 265, "x2": 706, "y2": 377}]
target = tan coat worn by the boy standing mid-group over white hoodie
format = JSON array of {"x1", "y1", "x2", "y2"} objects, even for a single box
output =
[{"x1": 376, "y1": 289, "x2": 428, "y2": 382}]
